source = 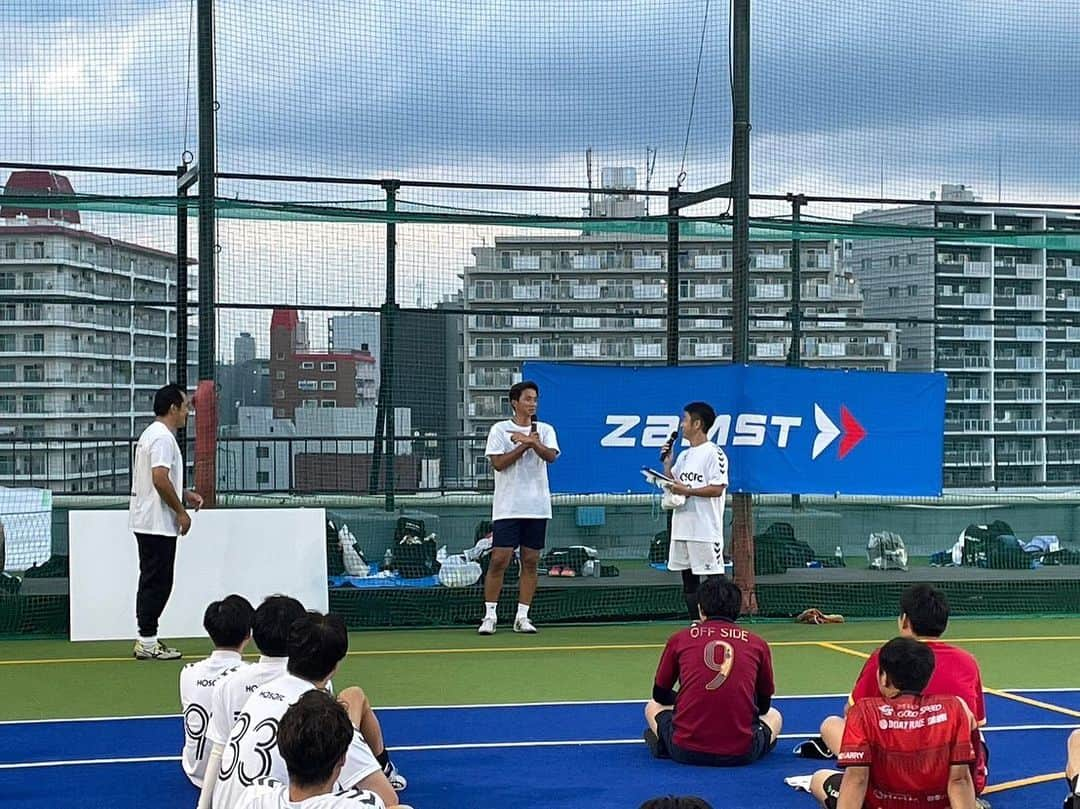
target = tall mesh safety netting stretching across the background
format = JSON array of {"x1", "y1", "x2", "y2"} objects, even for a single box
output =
[{"x1": 0, "y1": 0, "x2": 1080, "y2": 633}]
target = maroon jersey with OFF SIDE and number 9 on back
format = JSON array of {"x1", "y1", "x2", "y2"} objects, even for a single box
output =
[{"x1": 656, "y1": 618, "x2": 775, "y2": 756}]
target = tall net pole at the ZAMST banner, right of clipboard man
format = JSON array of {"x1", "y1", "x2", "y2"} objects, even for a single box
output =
[{"x1": 731, "y1": 0, "x2": 757, "y2": 615}]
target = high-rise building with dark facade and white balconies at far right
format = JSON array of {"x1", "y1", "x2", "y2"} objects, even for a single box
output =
[{"x1": 852, "y1": 186, "x2": 1080, "y2": 487}]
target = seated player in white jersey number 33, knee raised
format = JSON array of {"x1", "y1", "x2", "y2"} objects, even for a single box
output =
[{"x1": 213, "y1": 612, "x2": 405, "y2": 809}]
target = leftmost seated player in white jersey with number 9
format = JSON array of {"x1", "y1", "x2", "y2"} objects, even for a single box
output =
[{"x1": 180, "y1": 595, "x2": 255, "y2": 787}]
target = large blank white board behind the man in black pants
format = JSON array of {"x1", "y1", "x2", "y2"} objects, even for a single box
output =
[{"x1": 69, "y1": 509, "x2": 329, "y2": 641}]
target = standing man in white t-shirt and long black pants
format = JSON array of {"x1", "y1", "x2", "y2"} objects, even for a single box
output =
[{"x1": 127, "y1": 385, "x2": 203, "y2": 660}]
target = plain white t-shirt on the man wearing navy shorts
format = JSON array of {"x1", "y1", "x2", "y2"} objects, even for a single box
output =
[{"x1": 484, "y1": 419, "x2": 558, "y2": 521}]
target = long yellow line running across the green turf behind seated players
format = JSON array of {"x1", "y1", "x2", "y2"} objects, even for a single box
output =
[{"x1": 0, "y1": 635, "x2": 1080, "y2": 665}]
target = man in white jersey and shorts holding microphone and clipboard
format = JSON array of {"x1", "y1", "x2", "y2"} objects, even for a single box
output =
[{"x1": 663, "y1": 402, "x2": 728, "y2": 621}]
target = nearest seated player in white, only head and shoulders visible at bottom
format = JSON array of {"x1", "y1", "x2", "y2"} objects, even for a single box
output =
[{"x1": 237, "y1": 690, "x2": 408, "y2": 809}]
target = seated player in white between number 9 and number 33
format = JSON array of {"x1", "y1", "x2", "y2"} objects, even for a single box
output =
[{"x1": 199, "y1": 595, "x2": 306, "y2": 809}]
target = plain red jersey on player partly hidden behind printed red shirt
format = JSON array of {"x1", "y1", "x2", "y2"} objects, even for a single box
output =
[{"x1": 848, "y1": 641, "x2": 987, "y2": 795}]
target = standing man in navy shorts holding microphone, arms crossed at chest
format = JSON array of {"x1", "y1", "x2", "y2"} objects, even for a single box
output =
[{"x1": 478, "y1": 381, "x2": 558, "y2": 635}]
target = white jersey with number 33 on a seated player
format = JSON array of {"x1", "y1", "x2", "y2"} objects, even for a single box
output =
[{"x1": 213, "y1": 674, "x2": 382, "y2": 809}]
